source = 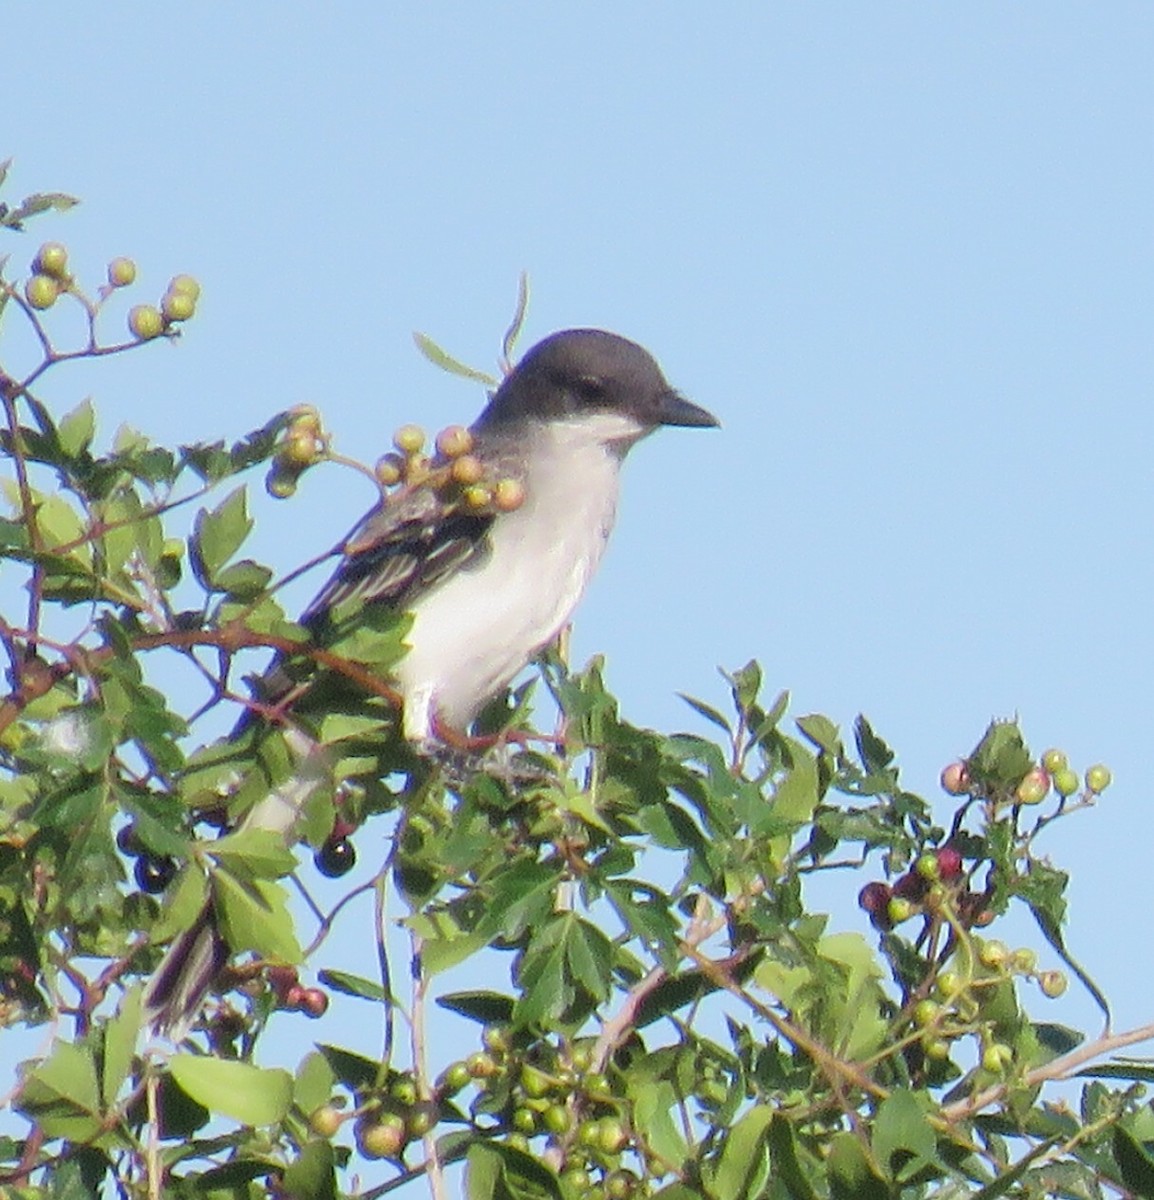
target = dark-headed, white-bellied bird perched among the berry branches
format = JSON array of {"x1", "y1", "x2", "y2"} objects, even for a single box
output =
[{"x1": 144, "y1": 329, "x2": 720, "y2": 1038}]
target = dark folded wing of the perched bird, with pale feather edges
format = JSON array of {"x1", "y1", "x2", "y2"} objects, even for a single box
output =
[{"x1": 301, "y1": 487, "x2": 494, "y2": 629}]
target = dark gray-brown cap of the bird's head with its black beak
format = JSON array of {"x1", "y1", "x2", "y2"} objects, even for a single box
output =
[{"x1": 477, "y1": 329, "x2": 719, "y2": 437}]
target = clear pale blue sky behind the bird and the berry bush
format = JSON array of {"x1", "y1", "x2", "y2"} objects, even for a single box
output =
[{"x1": 0, "y1": 0, "x2": 1154, "y2": 1161}]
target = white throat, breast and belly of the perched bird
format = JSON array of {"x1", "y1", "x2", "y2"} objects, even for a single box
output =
[{"x1": 397, "y1": 414, "x2": 641, "y2": 739}]
